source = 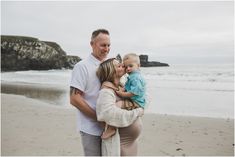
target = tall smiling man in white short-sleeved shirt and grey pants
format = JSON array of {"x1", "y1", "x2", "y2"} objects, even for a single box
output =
[{"x1": 70, "y1": 29, "x2": 110, "y2": 156}]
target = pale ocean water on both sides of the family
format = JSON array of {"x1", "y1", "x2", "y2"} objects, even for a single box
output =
[{"x1": 1, "y1": 64, "x2": 234, "y2": 118}]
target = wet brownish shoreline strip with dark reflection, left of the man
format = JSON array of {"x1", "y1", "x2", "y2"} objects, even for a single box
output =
[{"x1": 1, "y1": 81, "x2": 70, "y2": 107}]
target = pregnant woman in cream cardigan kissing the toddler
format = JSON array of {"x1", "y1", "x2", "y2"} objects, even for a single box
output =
[{"x1": 96, "y1": 58, "x2": 143, "y2": 156}]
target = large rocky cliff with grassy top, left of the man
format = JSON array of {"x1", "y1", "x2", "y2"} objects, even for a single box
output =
[{"x1": 1, "y1": 35, "x2": 81, "y2": 71}]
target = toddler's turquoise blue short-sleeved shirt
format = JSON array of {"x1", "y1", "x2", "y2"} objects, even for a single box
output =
[{"x1": 125, "y1": 70, "x2": 146, "y2": 108}]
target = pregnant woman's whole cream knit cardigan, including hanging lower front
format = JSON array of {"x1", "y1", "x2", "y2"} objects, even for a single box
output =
[{"x1": 96, "y1": 88, "x2": 143, "y2": 156}]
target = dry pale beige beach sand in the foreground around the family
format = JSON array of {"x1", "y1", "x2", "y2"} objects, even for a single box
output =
[{"x1": 1, "y1": 94, "x2": 234, "y2": 156}]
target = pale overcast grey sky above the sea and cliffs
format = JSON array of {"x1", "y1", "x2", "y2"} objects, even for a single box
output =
[{"x1": 1, "y1": 1, "x2": 234, "y2": 64}]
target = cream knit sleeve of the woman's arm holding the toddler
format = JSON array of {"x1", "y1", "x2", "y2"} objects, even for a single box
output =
[{"x1": 96, "y1": 88, "x2": 143, "y2": 127}]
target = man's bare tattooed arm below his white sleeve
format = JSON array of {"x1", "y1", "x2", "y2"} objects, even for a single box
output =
[{"x1": 70, "y1": 87, "x2": 97, "y2": 121}]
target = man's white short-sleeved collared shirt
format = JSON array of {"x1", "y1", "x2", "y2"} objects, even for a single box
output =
[{"x1": 70, "y1": 54, "x2": 102, "y2": 136}]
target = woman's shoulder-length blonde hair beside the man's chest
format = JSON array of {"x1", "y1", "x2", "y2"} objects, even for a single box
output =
[{"x1": 96, "y1": 58, "x2": 116, "y2": 84}]
